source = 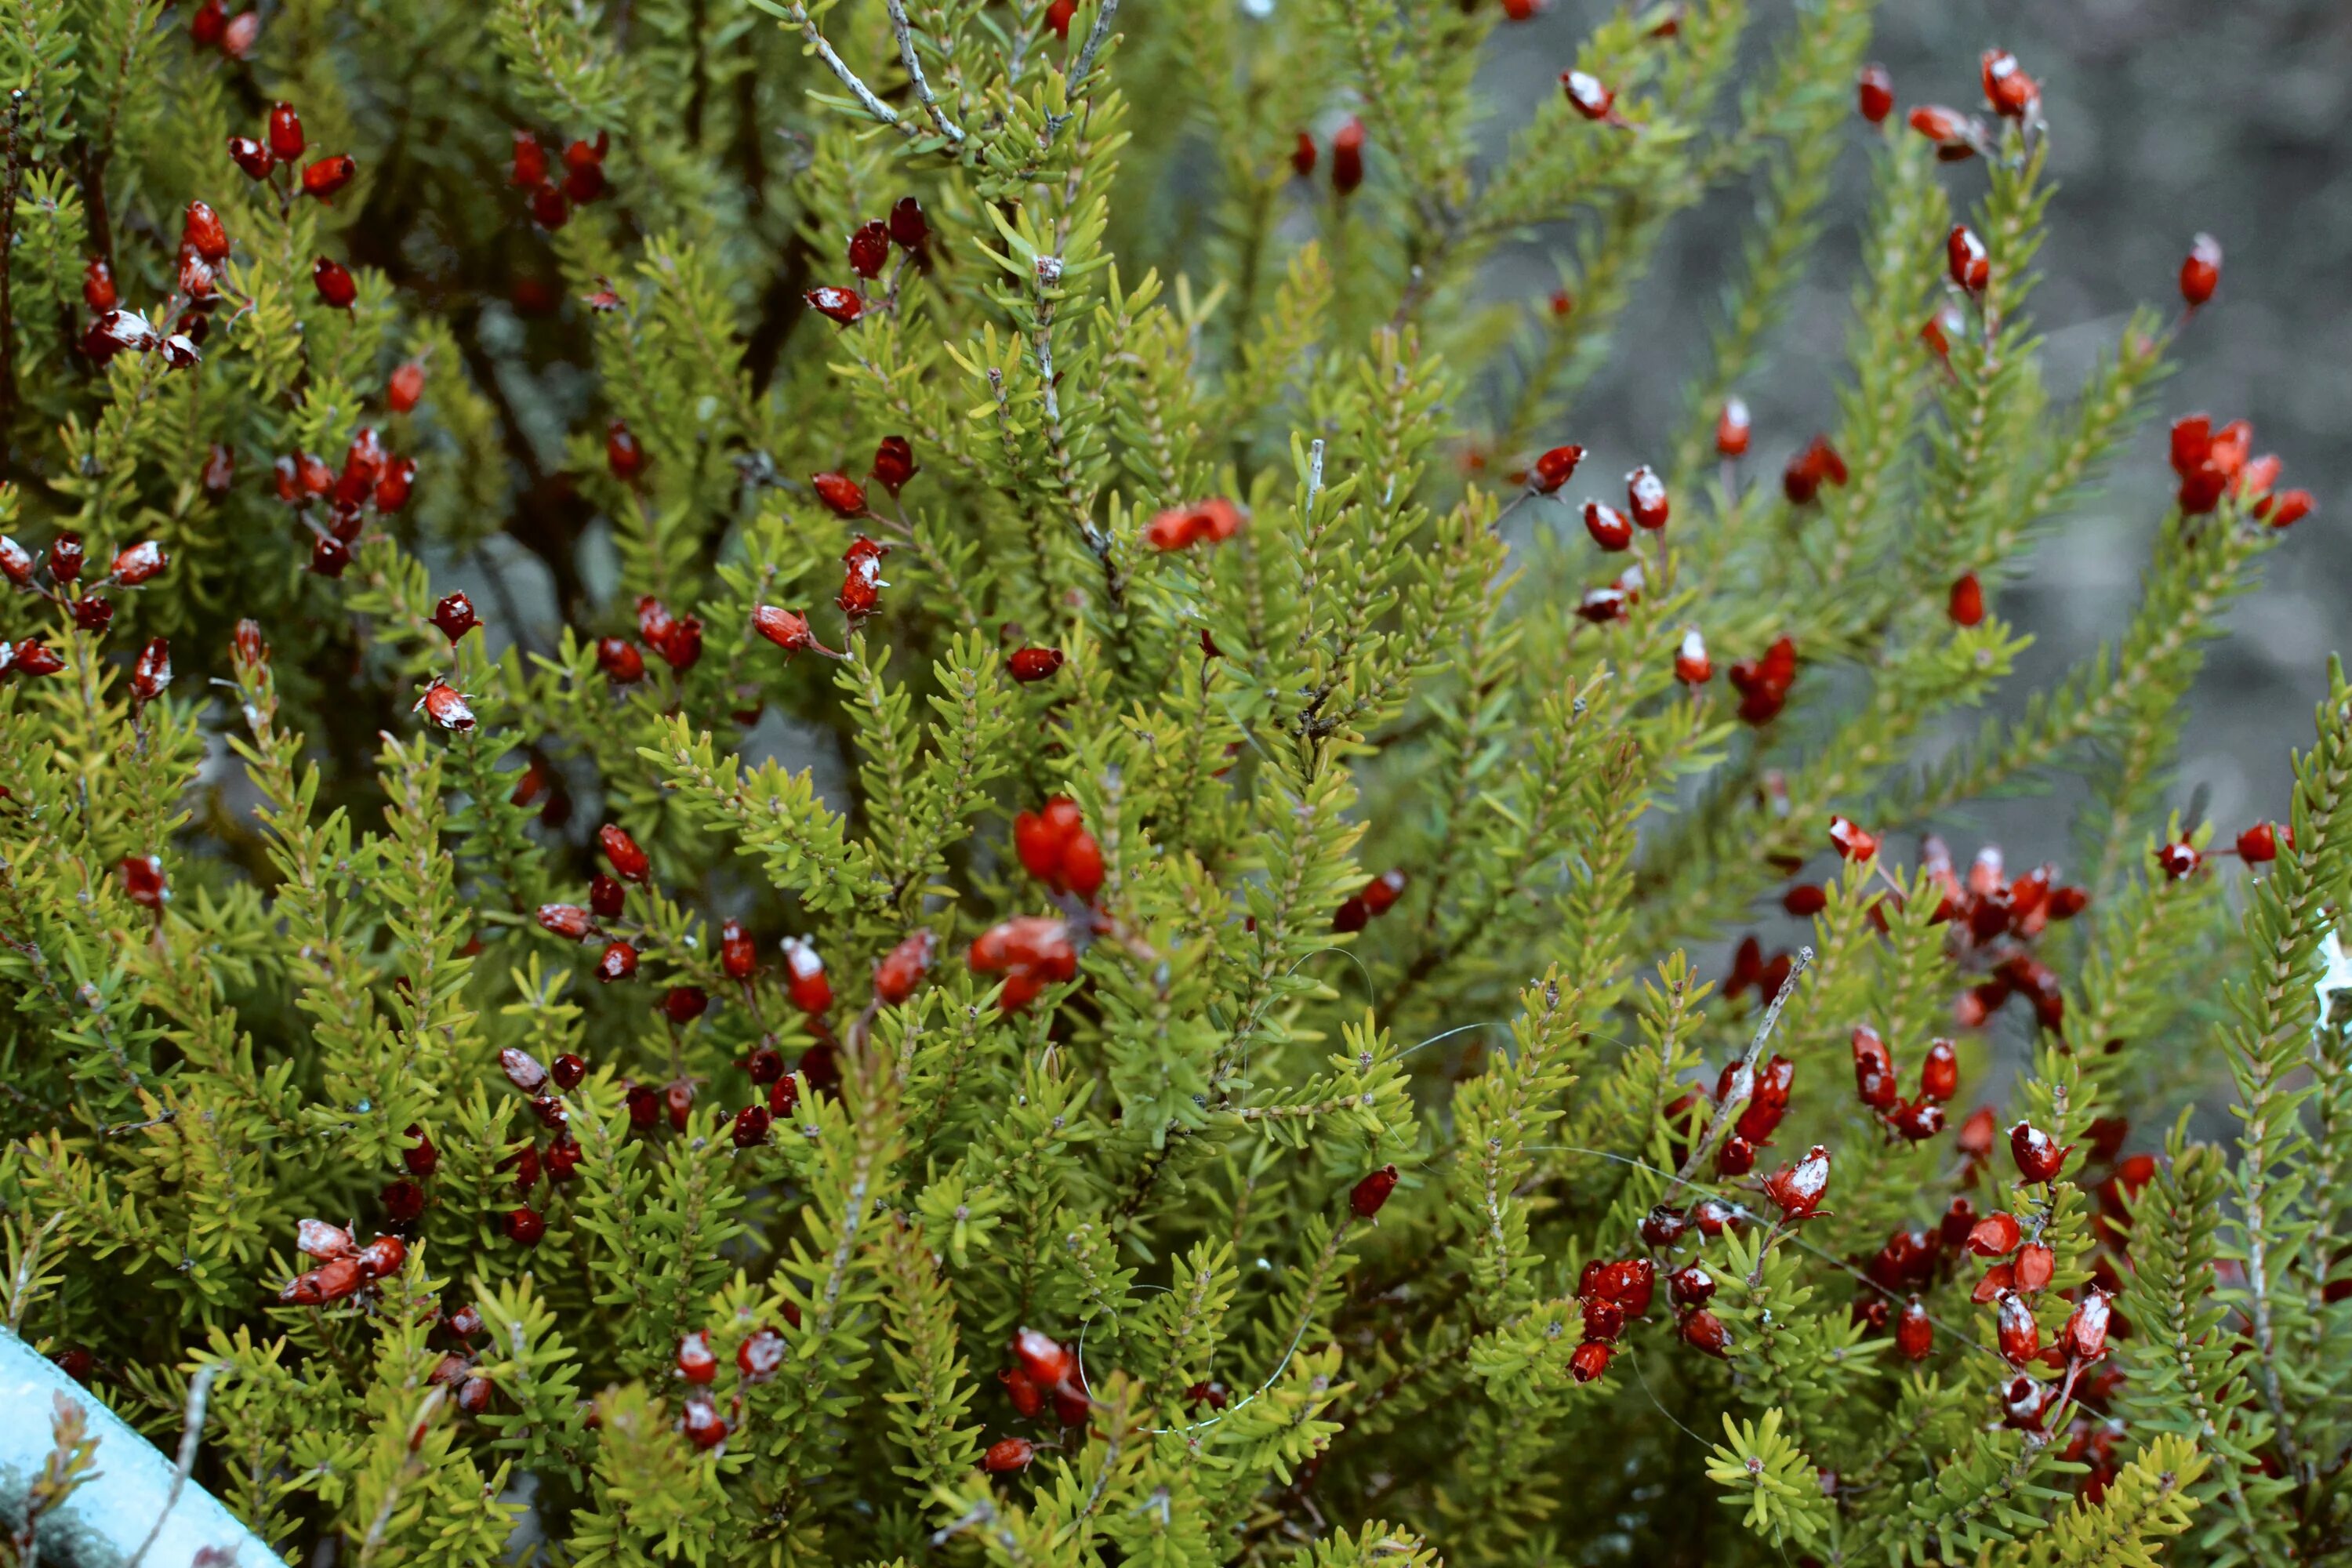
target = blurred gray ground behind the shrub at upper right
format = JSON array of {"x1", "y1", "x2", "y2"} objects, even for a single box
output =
[{"x1": 1489, "y1": 0, "x2": 2352, "y2": 862}]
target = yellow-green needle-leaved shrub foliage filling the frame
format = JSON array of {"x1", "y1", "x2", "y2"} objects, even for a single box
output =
[{"x1": 0, "y1": 0, "x2": 2352, "y2": 1568}]
